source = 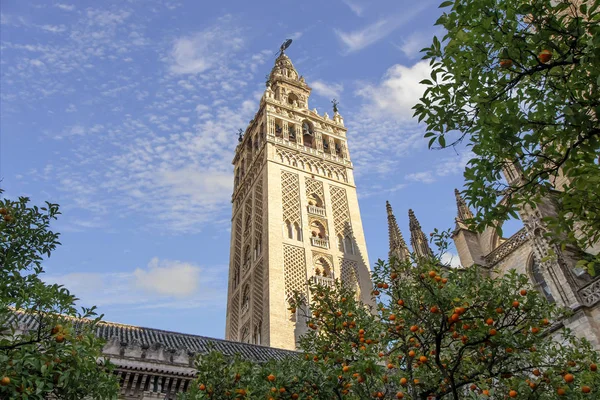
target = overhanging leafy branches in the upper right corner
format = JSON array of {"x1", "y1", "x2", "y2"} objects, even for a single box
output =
[{"x1": 414, "y1": 0, "x2": 600, "y2": 266}]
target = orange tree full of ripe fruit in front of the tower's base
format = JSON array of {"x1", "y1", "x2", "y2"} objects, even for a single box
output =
[{"x1": 182, "y1": 234, "x2": 600, "y2": 400}]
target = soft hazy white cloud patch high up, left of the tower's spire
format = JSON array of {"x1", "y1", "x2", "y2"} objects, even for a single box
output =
[{"x1": 169, "y1": 16, "x2": 243, "y2": 74}]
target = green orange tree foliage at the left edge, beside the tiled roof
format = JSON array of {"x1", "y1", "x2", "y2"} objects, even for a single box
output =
[{"x1": 0, "y1": 192, "x2": 118, "y2": 400}]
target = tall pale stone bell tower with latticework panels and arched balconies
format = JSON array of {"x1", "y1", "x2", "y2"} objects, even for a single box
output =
[{"x1": 225, "y1": 50, "x2": 372, "y2": 349}]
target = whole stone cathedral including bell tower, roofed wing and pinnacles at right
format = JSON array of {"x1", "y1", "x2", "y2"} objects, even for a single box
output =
[{"x1": 14, "y1": 50, "x2": 600, "y2": 400}]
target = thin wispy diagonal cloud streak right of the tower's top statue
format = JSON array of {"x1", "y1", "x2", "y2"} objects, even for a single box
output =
[{"x1": 334, "y1": 1, "x2": 427, "y2": 53}]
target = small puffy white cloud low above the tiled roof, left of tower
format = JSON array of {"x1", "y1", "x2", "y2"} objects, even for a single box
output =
[{"x1": 133, "y1": 257, "x2": 200, "y2": 297}]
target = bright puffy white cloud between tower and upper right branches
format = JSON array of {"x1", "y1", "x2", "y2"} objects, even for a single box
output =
[{"x1": 357, "y1": 61, "x2": 431, "y2": 120}]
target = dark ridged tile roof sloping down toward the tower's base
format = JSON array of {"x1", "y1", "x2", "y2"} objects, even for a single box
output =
[{"x1": 10, "y1": 312, "x2": 298, "y2": 362}]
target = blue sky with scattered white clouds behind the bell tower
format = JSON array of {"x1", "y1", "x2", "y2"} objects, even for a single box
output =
[{"x1": 0, "y1": 0, "x2": 510, "y2": 337}]
